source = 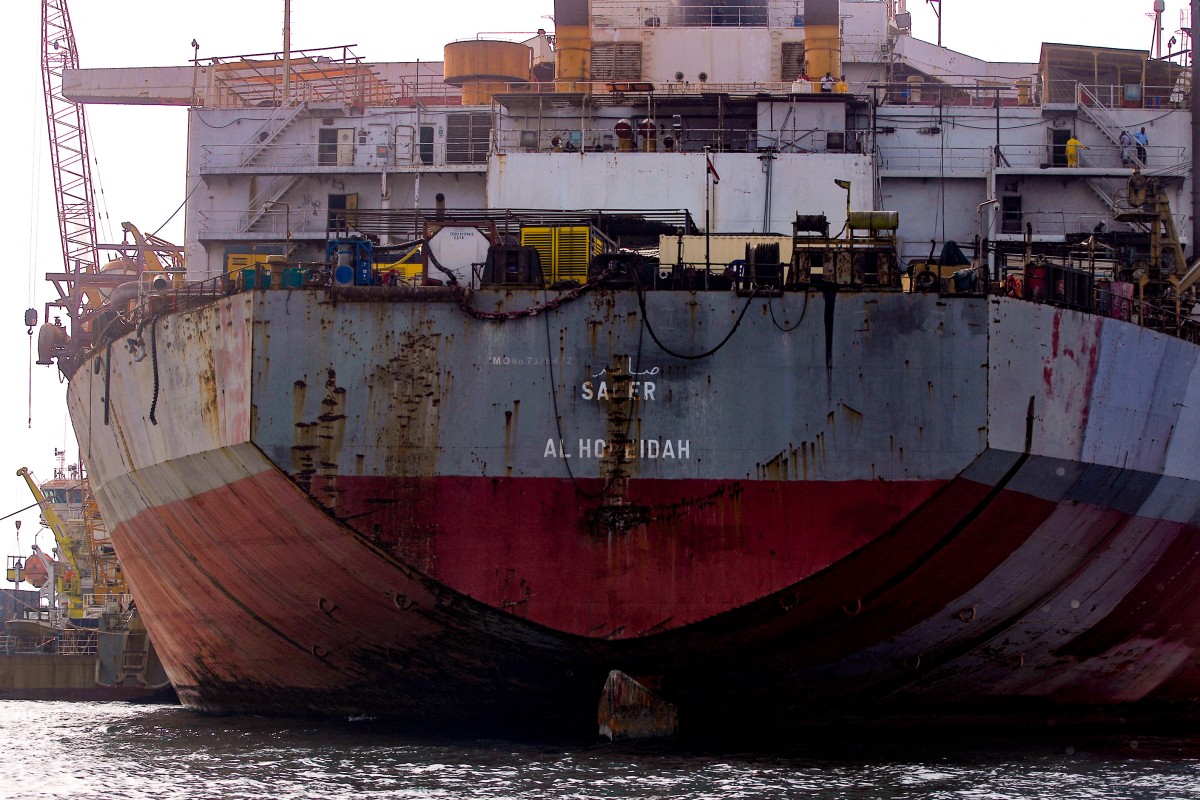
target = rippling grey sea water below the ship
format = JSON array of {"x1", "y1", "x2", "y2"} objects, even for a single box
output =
[{"x1": 0, "y1": 702, "x2": 1200, "y2": 800}]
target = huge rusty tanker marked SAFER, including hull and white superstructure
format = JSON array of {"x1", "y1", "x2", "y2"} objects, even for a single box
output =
[{"x1": 40, "y1": 0, "x2": 1200, "y2": 735}]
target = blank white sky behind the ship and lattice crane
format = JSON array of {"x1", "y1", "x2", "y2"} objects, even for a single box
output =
[{"x1": 0, "y1": 0, "x2": 1187, "y2": 566}]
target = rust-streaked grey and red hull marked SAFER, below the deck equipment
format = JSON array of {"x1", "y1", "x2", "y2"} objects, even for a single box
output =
[{"x1": 68, "y1": 287, "x2": 1200, "y2": 733}]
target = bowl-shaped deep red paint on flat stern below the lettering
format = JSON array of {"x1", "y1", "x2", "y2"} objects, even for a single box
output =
[{"x1": 313, "y1": 476, "x2": 943, "y2": 637}]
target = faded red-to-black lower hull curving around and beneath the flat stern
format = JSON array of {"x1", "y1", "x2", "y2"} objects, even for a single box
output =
[{"x1": 98, "y1": 450, "x2": 1200, "y2": 732}]
